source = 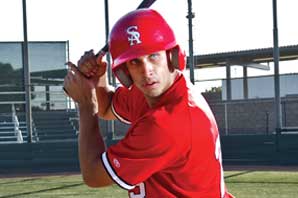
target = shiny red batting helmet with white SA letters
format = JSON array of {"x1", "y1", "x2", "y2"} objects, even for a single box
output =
[{"x1": 109, "y1": 9, "x2": 185, "y2": 87}]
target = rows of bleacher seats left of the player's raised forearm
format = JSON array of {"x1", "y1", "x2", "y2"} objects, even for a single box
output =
[{"x1": 0, "y1": 111, "x2": 78, "y2": 144}]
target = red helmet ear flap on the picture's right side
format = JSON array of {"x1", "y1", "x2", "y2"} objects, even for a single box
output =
[{"x1": 169, "y1": 45, "x2": 186, "y2": 71}]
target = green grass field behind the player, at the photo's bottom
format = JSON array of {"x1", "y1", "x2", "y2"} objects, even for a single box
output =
[{"x1": 0, "y1": 171, "x2": 298, "y2": 198}]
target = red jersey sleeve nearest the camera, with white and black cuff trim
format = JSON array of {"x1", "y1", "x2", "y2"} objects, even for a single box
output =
[{"x1": 102, "y1": 117, "x2": 181, "y2": 190}]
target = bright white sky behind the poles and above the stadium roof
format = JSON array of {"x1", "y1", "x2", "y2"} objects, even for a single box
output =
[{"x1": 0, "y1": 0, "x2": 298, "y2": 90}]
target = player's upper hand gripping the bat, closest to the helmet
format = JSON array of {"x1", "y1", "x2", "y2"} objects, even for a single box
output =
[{"x1": 78, "y1": 50, "x2": 107, "y2": 78}]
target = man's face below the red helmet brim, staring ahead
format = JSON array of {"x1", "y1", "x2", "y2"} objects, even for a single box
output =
[{"x1": 126, "y1": 51, "x2": 175, "y2": 99}]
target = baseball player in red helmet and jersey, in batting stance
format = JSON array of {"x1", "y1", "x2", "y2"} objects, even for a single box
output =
[{"x1": 64, "y1": 9, "x2": 233, "y2": 198}]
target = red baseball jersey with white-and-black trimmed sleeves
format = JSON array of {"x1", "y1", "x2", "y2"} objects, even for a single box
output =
[{"x1": 102, "y1": 75, "x2": 234, "y2": 198}]
